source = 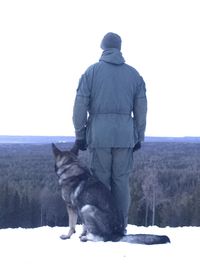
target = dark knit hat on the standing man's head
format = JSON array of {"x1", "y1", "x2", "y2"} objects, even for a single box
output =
[{"x1": 101, "y1": 32, "x2": 122, "y2": 50}]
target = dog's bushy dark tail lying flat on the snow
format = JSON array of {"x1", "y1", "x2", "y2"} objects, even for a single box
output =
[{"x1": 120, "y1": 234, "x2": 170, "y2": 245}]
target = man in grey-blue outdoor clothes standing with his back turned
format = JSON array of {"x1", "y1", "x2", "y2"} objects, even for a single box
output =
[{"x1": 73, "y1": 32, "x2": 147, "y2": 227}]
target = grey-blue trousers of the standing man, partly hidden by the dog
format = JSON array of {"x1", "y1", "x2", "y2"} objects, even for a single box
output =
[{"x1": 89, "y1": 148, "x2": 133, "y2": 227}]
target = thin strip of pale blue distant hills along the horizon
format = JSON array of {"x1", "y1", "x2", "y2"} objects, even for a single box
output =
[{"x1": 0, "y1": 135, "x2": 200, "y2": 144}]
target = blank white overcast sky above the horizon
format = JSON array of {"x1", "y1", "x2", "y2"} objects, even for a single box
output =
[{"x1": 0, "y1": 0, "x2": 200, "y2": 136}]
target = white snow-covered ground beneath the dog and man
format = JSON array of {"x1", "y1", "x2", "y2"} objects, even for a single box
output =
[{"x1": 0, "y1": 225, "x2": 200, "y2": 267}]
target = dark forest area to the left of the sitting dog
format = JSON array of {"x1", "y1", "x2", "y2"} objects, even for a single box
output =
[{"x1": 0, "y1": 144, "x2": 68, "y2": 228}]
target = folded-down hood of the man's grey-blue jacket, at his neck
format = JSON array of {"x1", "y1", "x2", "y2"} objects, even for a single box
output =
[{"x1": 99, "y1": 48, "x2": 125, "y2": 65}]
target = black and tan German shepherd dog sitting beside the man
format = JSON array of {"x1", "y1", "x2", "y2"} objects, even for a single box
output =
[{"x1": 52, "y1": 144, "x2": 170, "y2": 245}]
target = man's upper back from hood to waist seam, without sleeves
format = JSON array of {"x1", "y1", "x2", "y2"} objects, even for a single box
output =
[{"x1": 89, "y1": 49, "x2": 140, "y2": 115}]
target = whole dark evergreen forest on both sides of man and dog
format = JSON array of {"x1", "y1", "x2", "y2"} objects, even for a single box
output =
[{"x1": 0, "y1": 142, "x2": 200, "y2": 228}]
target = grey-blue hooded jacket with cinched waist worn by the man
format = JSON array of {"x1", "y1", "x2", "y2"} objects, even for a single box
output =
[{"x1": 73, "y1": 48, "x2": 147, "y2": 148}]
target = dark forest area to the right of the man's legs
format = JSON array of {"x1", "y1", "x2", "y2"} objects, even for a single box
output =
[{"x1": 130, "y1": 143, "x2": 200, "y2": 227}]
